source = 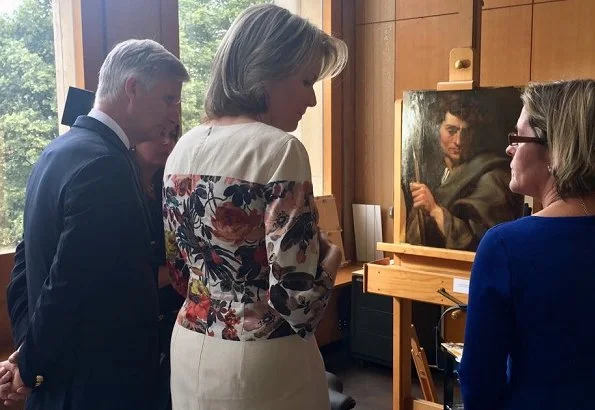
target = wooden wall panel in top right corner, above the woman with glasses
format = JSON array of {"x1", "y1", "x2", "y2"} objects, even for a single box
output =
[{"x1": 531, "y1": 0, "x2": 595, "y2": 81}]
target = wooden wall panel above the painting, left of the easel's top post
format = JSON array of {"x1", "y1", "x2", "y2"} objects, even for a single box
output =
[{"x1": 395, "y1": 14, "x2": 463, "y2": 98}]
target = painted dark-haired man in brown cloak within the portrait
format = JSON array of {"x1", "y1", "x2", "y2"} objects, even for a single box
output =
[{"x1": 407, "y1": 93, "x2": 522, "y2": 251}]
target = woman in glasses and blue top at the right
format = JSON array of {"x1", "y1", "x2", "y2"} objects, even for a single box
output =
[{"x1": 460, "y1": 80, "x2": 595, "y2": 410}]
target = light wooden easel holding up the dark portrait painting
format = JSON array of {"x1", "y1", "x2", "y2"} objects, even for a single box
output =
[{"x1": 364, "y1": 0, "x2": 482, "y2": 410}]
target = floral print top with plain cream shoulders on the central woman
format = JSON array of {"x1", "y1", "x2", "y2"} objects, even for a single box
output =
[{"x1": 163, "y1": 125, "x2": 332, "y2": 341}]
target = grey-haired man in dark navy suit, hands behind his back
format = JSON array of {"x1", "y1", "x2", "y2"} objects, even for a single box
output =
[{"x1": 0, "y1": 40, "x2": 188, "y2": 410}]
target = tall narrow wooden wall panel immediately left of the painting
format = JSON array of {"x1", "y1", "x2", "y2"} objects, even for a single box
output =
[{"x1": 354, "y1": 22, "x2": 395, "y2": 242}]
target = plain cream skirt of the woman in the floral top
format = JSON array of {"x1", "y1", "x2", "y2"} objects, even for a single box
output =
[{"x1": 171, "y1": 323, "x2": 330, "y2": 410}]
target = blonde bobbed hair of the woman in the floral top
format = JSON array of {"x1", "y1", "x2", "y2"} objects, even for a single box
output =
[{"x1": 205, "y1": 4, "x2": 347, "y2": 119}]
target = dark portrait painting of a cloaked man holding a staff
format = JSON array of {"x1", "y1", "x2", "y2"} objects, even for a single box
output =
[{"x1": 401, "y1": 87, "x2": 523, "y2": 251}]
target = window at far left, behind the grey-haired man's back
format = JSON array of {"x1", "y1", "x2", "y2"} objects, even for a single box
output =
[{"x1": 0, "y1": 0, "x2": 58, "y2": 249}]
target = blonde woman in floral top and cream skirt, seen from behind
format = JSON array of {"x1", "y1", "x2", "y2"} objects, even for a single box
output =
[{"x1": 164, "y1": 5, "x2": 347, "y2": 410}]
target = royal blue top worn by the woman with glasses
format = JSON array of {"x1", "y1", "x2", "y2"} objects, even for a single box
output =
[{"x1": 459, "y1": 216, "x2": 595, "y2": 410}]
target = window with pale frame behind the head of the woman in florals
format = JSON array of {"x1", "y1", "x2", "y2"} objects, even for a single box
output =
[{"x1": 179, "y1": 0, "x2": 323, "y2": 195}]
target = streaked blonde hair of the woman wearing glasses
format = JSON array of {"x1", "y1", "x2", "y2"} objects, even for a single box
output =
[{"x1": 521, "y1": 80, "x2": 595, "y2": 199}]
